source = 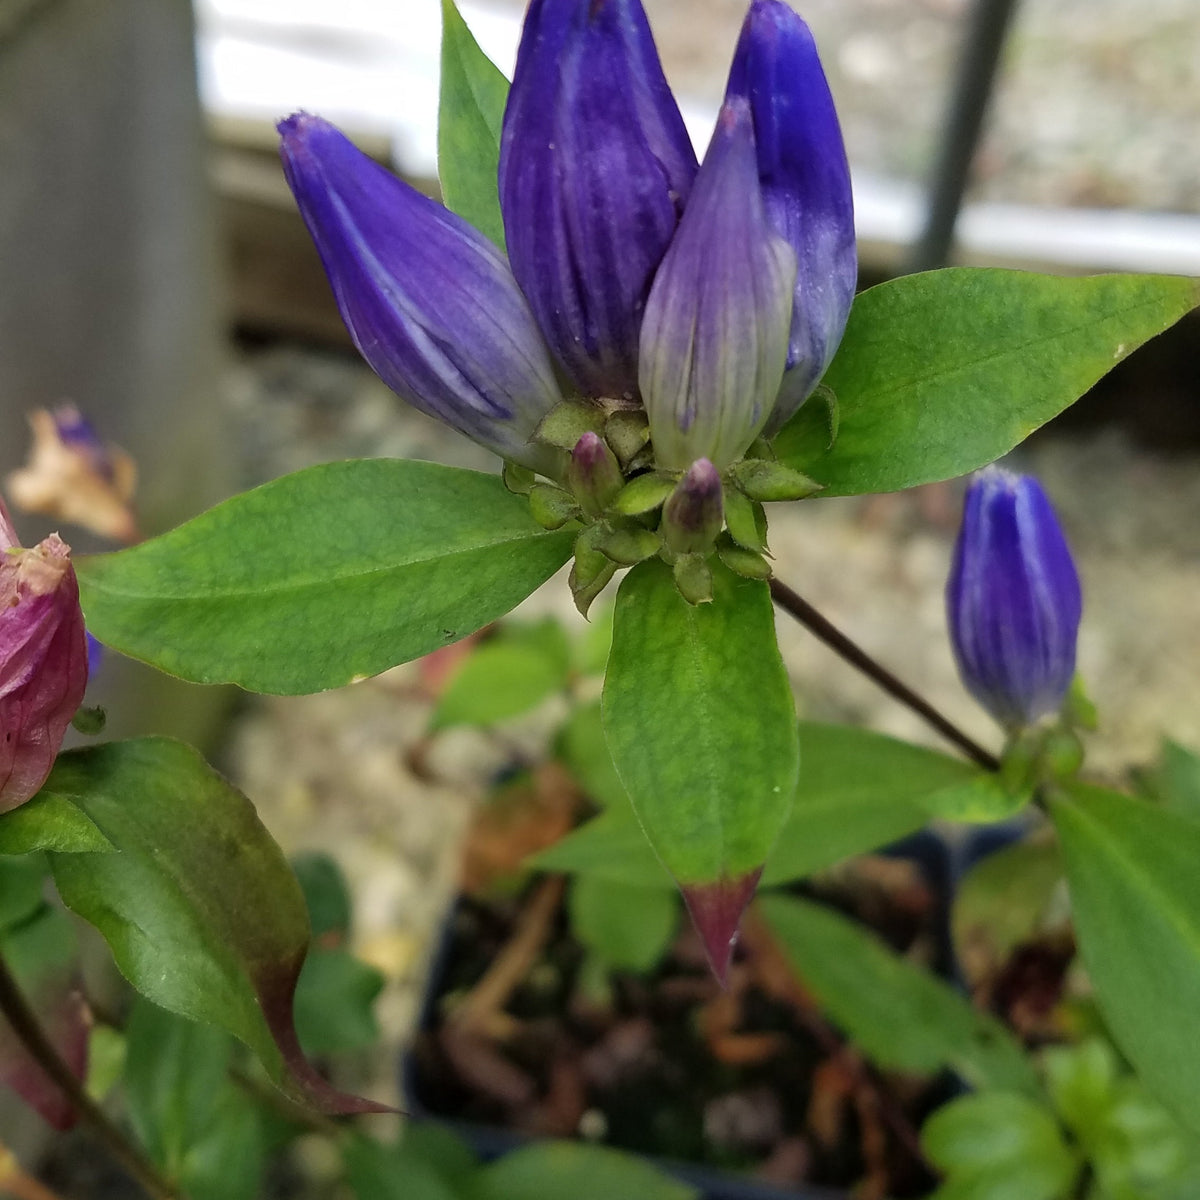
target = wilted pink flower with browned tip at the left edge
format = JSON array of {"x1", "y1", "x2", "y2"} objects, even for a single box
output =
[{"x1": 0, "y1": 500, "x2": 88, "y2": 812}]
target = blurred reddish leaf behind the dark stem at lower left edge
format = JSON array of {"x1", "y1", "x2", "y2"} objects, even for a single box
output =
[{"x1": 0, "y1": 906, "x2": 91, "y2": 1130}]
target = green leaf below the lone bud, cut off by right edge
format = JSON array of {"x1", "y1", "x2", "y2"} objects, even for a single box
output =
[{"x1": 1050, "y1": 785, "x2": 1200, "y2": 1132}]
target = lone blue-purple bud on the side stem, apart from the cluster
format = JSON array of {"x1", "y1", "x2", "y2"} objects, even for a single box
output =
[{"x1": 946, "y1": 467, "x2": 1082, "y2": 728}]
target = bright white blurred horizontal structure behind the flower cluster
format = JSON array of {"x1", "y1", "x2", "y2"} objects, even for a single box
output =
[{"x1": 196, "y1": 0, "x2": 1200, "y2": 275}]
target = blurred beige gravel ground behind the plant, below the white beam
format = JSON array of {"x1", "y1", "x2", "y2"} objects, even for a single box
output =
[{"x1": 220, "y1": 347, "x2": 1200, "y2": 1094}]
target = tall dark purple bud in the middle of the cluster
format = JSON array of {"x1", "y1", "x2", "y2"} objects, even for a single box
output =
[{"x1": 499, "y1": 0, "x2": 696, "y2": 398}]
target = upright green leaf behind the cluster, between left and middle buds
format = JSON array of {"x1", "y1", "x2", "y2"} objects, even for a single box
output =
[{"x1": 438, "y1": 0, "x2": 509, "y2": 251}]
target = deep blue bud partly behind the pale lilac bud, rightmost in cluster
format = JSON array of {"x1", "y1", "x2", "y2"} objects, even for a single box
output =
[{"x1": 726, "y1": 0, "x2": 858, "y2": 436}]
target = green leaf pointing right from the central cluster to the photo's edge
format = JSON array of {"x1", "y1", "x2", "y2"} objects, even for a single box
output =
[{"x1": 775, "y1": 268, "x2": 1200, "y2": 496}]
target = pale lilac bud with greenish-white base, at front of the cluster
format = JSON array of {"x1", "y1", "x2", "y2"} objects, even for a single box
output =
[{"x1": 640, "y1": 100, "x2": 796, "y2": 472}]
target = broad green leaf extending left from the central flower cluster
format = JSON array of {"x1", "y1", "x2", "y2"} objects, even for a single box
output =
[{"x1": 77, "y1": 458, "x2": 574, "y2": 695}]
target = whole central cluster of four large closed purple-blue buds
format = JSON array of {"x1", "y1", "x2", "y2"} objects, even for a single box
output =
[{"x1": 280, "y1": 0, "x2": 854, "y2": 479}]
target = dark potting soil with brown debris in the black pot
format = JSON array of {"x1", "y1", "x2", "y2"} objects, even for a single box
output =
[{"x1": 409, "y1": 883, "x2": 954, "y2": 1200}]
